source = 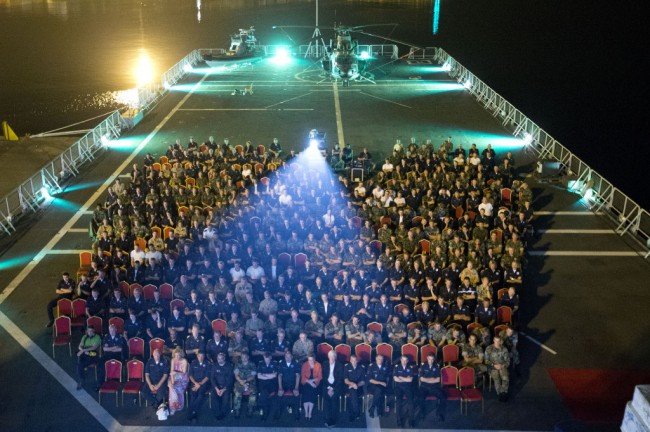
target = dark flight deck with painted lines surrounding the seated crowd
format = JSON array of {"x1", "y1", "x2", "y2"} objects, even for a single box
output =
[{"x1": 0, "y1": 58, "x2": 650, "y2": 431}]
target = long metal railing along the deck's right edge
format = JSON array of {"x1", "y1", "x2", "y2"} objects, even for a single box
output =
[{"x1": 430, "y1": 48, "x2": 650, "y2": 258}]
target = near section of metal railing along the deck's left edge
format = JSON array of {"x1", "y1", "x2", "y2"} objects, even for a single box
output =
[{"x1": 0, "y1": 111, "x2": 126, "y2": 235}]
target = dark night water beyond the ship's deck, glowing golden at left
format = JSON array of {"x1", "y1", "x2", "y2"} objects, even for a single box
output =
[{"x1": 0, "y1": 0, "x2": 650, "y2": 208}]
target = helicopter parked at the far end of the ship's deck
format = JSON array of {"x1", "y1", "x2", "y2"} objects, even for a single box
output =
[{"x1": 273, "y1": 24, "x2": 421, "y2": 87}]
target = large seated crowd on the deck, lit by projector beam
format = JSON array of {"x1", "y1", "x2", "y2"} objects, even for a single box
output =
[{"x1": 48, "y1": 137, "x2": 533, "y2": 426}]
